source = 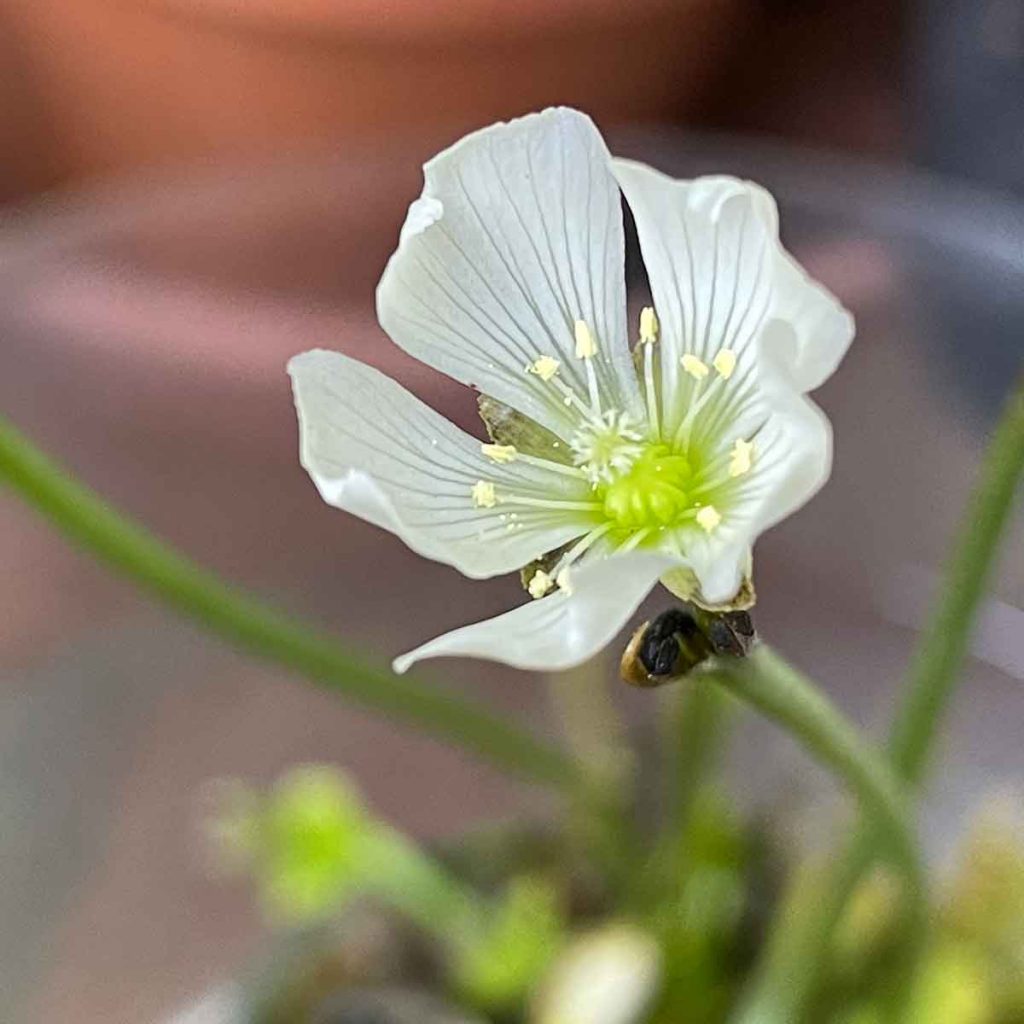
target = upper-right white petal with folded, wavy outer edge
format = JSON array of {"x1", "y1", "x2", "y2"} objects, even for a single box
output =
[{"x1": 612, "y1": 160, "x2": 854, "y2": 413}]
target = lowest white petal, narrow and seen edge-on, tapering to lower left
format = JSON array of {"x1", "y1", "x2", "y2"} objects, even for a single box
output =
[{"x1": 394, "y1": 553, "x2": 678, "y2": 672}]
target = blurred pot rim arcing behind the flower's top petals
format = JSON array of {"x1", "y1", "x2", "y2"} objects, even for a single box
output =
[{"x1": 8, "y1": 128, "x2": 1024, "y2": 274}]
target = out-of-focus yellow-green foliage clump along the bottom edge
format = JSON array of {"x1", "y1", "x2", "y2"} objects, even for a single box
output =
[{"x1": 207, "y1": 766, "x2": 1024, "y2": 1024}]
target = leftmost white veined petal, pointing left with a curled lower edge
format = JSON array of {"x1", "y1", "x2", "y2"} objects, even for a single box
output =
[{"x1": 288, "y1": 351, "x2": 591, "y2": 577}]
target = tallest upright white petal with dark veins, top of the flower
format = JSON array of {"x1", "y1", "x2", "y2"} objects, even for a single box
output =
[{"x1": 377, "y1": 109, "x2": 643, "y2": 438}]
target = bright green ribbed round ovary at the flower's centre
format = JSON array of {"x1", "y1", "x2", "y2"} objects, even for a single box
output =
[{"x1": 598, "y1": 444, "x2": 693, "y2": 530}]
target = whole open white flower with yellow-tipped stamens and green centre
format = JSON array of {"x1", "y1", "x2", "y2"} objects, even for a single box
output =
[{"x1": 289, "y1": 109, "x2": 853, "y2": 671}]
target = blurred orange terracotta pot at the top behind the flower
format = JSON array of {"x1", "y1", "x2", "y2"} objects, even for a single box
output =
[{"x1": 0, "y1": 0, "x2": 749, "y2": 186}]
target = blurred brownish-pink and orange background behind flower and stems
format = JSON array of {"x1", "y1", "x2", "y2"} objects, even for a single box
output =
[{"x1": 0, "y1": 0, "x2": 1024, "y2": 1022}]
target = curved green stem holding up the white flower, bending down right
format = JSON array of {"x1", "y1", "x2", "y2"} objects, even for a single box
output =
[{"x1": 698, "y1": 644, "x2": 927, "y2": 920}]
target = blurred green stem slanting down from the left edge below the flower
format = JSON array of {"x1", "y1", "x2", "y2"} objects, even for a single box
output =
[{"x1": 0, "y1": 418, "x2": 577, "y2": 786}]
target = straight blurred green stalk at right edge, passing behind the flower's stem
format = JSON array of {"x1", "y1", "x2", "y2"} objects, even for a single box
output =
[{"x1": 737, "y1": 379, "x2": 1024, "y2": 1024}]
